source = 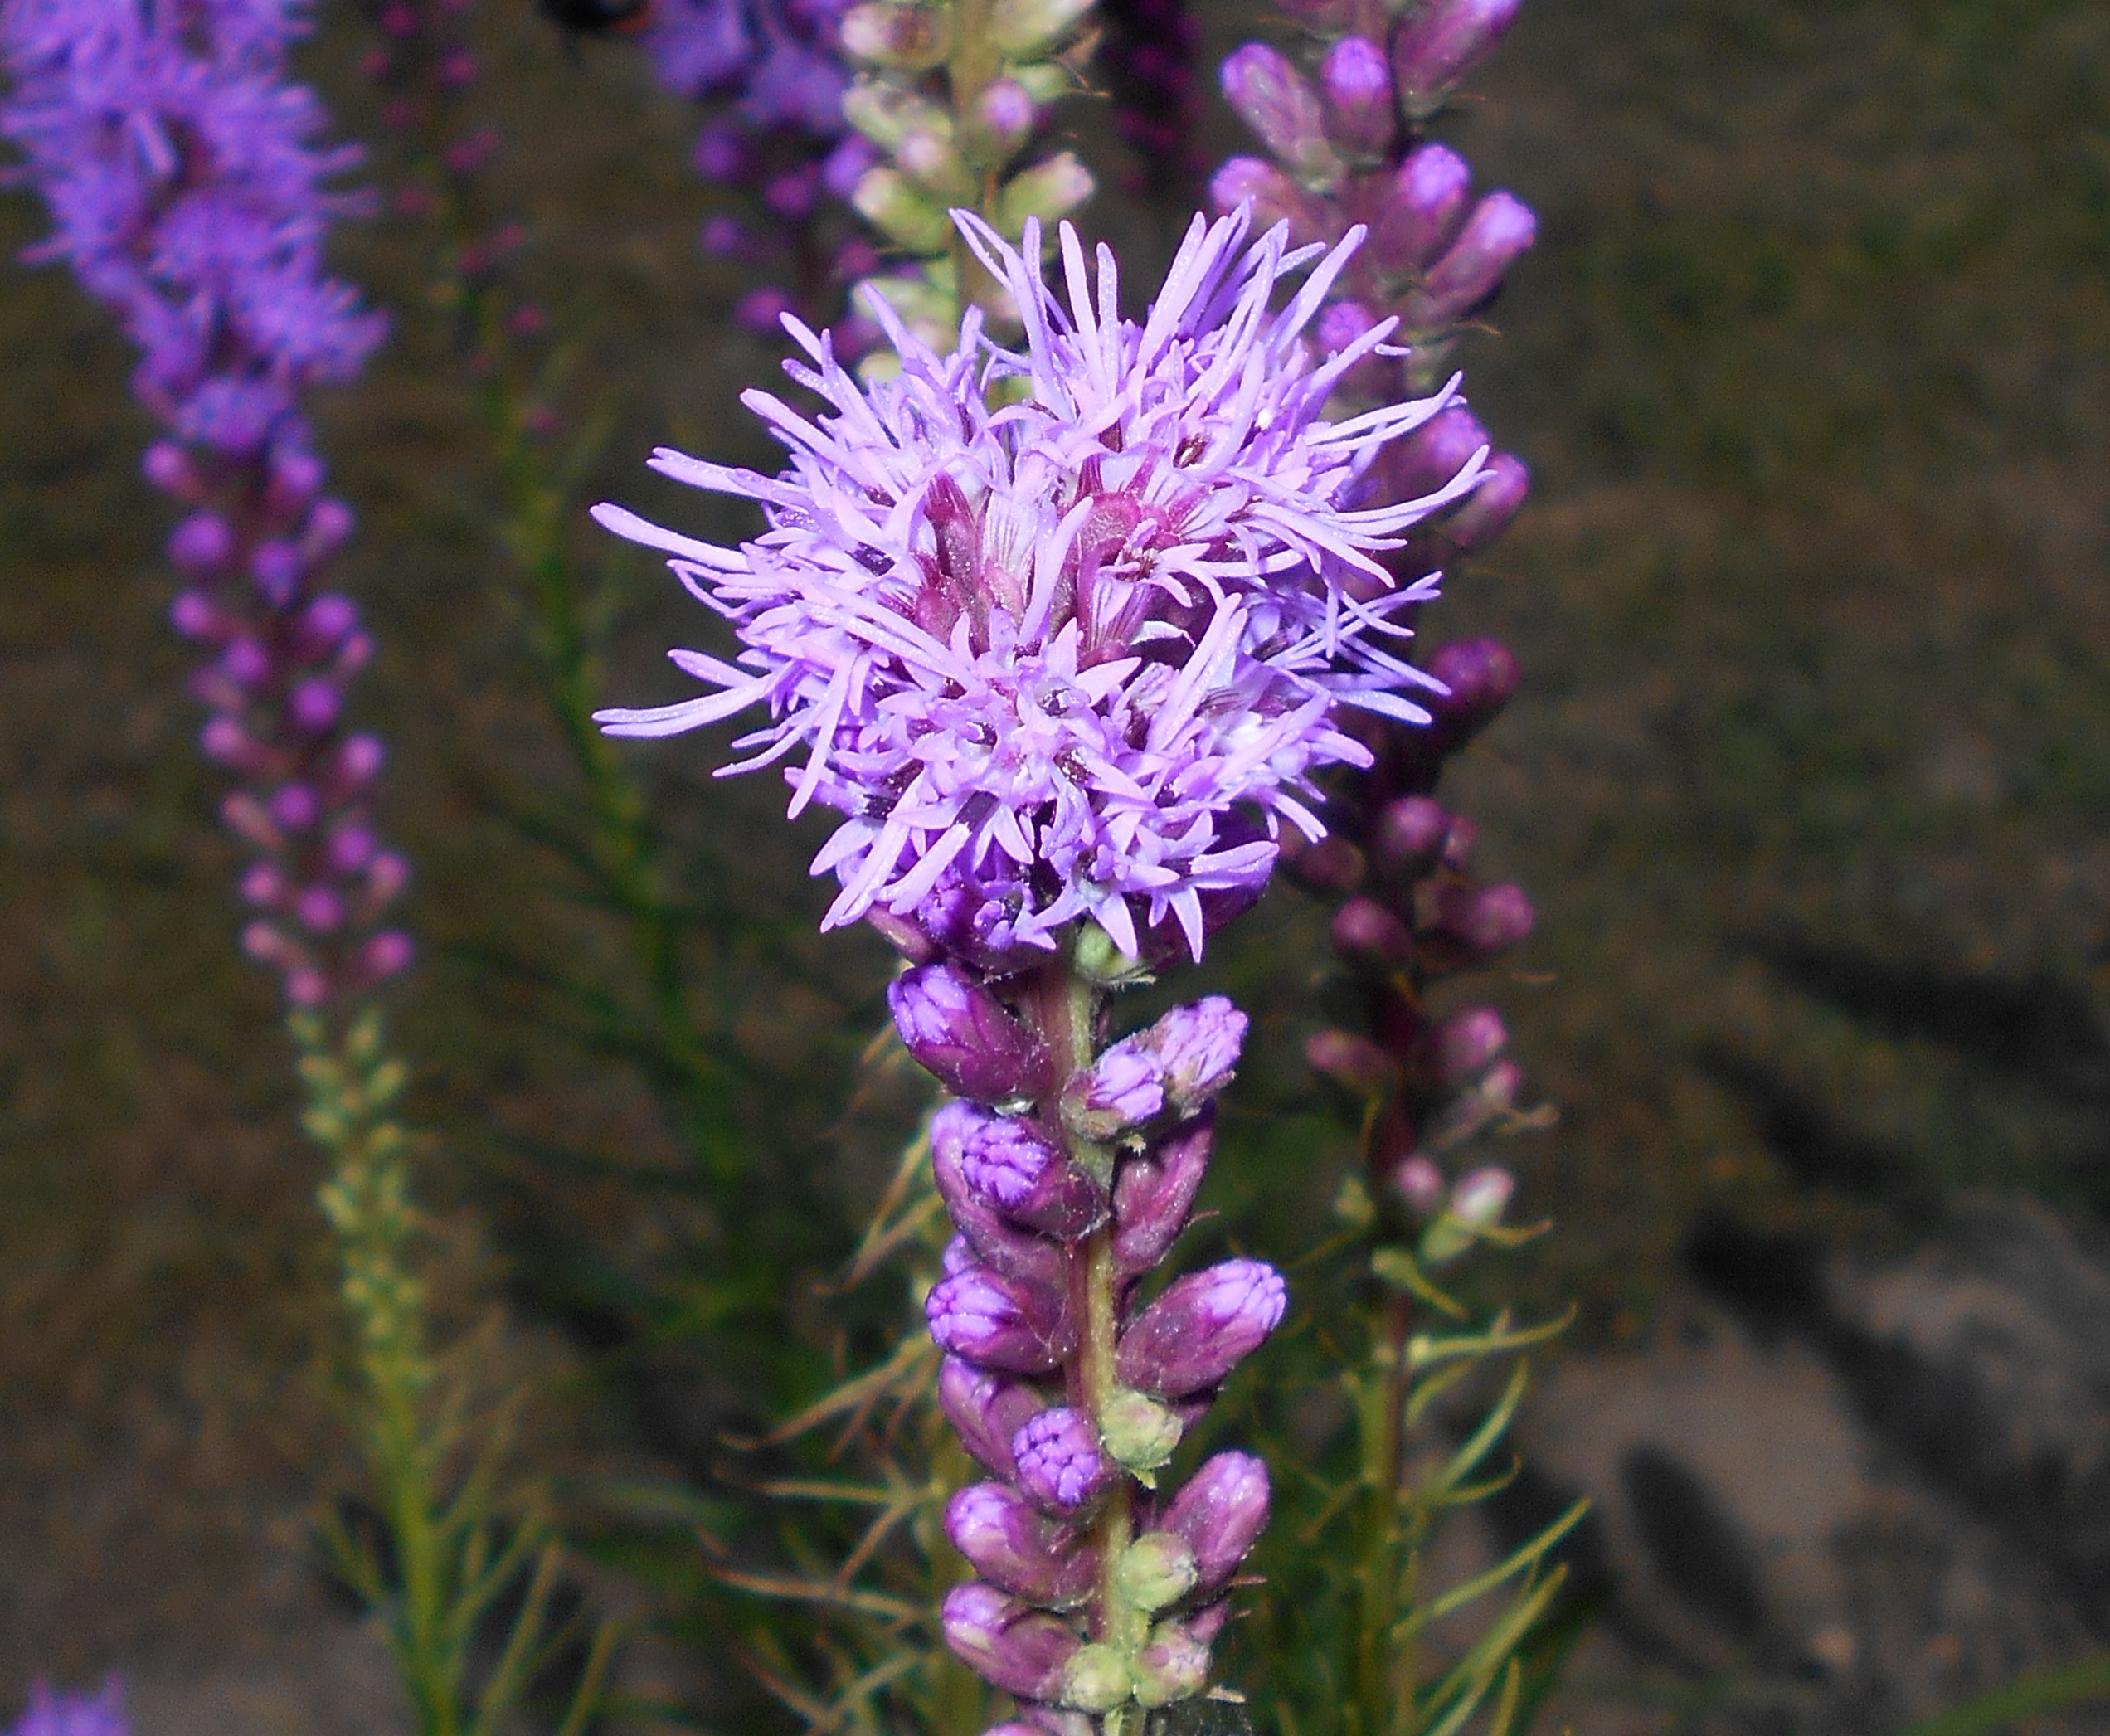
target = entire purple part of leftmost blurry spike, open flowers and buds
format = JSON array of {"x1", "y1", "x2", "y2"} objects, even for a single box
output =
[{"x1": 0, "y1": 0, "x2": 410, "y2": 1006}]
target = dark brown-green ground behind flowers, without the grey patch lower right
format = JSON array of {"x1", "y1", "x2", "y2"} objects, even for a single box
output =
[{"x1": 0, "y1": 0, "x2": 2110, "y2": 1736}]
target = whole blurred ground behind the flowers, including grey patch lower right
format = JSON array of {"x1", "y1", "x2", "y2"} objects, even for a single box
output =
[{"x1": 0, "y1": 0, "x2": 2110, "y2": 1736}]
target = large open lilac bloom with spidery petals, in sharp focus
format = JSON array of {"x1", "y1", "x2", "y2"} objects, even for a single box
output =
[{"x1": 595, "y1": 211, "x2": 1479, "y2": 956}]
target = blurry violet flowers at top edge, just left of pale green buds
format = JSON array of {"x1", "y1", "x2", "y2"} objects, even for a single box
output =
[{"x1": 644, "y1": 0, "x2": 878, "y2": 333}]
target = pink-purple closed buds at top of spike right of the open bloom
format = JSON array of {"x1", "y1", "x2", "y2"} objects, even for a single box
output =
[{"x1": 1211, "y1": 0, "x2": 1539, "y2": 576}]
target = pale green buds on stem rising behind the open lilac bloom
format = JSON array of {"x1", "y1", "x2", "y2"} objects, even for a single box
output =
[{"x1": 842, "y1": 0, "x2": 1095, "y2": 350}]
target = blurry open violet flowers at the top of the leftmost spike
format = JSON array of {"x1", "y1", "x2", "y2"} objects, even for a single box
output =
[{"x1": 0, "y1": 0, "x2": 384, "y2": 454}]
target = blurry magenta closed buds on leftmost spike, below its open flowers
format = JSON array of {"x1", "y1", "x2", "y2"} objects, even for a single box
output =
[{"x1": 161, "y1": 441, "x2": 411, "y2": 1009}]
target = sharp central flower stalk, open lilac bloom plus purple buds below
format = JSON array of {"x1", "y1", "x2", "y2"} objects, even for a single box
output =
[{"x1": 597, "y1": 211, "x2": 1479, "y2": 1736}]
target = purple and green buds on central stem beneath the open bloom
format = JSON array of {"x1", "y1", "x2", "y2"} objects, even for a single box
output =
[{"x1": 891, "y1": 949, "x2": 1285, "y2": 1736}]
